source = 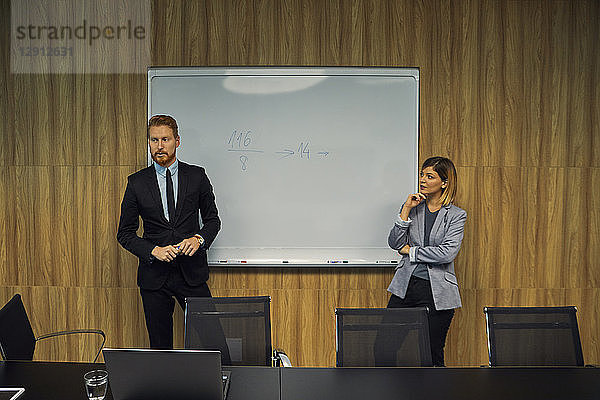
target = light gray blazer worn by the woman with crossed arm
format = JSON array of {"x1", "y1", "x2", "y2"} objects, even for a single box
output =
[{"x1": 388, "y1": 202, "x2": 467, "y2": 310}]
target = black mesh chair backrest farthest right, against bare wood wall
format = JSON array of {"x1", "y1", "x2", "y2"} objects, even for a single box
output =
[{"x1": 483, "y1": 307, "x2": 583, "y2": 367}]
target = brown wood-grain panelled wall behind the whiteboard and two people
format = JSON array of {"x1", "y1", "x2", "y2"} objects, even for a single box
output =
[{"x1": 0, "y1": 0, "x2": 600, "y2": 366}]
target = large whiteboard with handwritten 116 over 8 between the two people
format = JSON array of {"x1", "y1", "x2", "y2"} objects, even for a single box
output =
[{"x1": 148, "y1": 67, "x2": 419, "y2": 266}]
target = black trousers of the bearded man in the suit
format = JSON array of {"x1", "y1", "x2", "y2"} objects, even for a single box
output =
[{"x1": 140, "y1": 265, "x2": 211, "y2": 349}]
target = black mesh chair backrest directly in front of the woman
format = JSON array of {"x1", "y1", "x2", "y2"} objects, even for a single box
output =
[{"x1": 335, "y1": 307, "x2": 432, "y2": 367}]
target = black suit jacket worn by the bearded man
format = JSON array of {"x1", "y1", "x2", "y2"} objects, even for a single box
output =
[{"x1": 117, "y1": 161, "x2": 221, "y2": 290}]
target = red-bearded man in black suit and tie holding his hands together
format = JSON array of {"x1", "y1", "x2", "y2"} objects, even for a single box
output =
[{"x1": 117, "y1": 115, "x2": 221, "y2": 349}]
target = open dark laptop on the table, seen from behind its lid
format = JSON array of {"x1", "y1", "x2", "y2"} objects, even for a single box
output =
[{"x1": 102, "y1": 348, "x2": 231, "y2": 400}]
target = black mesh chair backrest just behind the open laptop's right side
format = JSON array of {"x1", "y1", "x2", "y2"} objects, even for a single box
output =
[{"x1": 185, "y1": 296, "x2": 272, "y2": 366}]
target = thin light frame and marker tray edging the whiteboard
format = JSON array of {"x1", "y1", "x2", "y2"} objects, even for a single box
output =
[{"x1": 146, "y1": 66, "x2": 420, "y2": 267}]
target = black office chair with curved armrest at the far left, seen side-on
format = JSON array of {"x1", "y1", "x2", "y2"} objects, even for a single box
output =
[{"x1": 0, "y1": 294, "x2": 106, "y2": 362}]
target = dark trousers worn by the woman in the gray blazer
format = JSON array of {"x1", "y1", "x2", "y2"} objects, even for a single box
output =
[{"x1": 387, "y1": 276, "x2": 454, "y2": 367}]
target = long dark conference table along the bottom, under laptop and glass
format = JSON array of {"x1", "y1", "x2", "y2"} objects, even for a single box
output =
[{"x1": 0, "y1": 361, "x2": 600, "y2": 400}]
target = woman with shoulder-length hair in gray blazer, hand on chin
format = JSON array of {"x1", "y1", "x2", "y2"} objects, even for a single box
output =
[{"x1": 388, "y1": 157, "x2": 467, "y2": 367}]
